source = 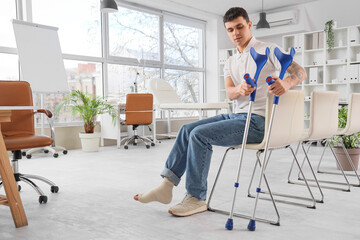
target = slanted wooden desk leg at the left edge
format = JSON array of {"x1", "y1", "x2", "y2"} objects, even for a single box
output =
[{"x1": 0, "y1": 132, "x2": 28, "y2": 228}]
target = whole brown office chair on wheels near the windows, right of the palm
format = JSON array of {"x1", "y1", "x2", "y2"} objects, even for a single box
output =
[{"x1": 120, "y1": 93, "x2": 155, "y2": 149}]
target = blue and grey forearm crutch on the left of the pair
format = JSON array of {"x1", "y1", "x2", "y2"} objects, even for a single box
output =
[{"x1": 225, "y1": 47, "x2": 270, "y2": 230}]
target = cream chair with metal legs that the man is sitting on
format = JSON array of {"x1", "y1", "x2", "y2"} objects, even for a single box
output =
[{"x1": 208, "y1": 91, "x2": 316, "y2": 225}]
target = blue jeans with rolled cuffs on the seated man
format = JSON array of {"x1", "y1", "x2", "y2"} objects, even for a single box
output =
[{"x1": 161, "y1": 113, "x2": 265, "y2": 200}]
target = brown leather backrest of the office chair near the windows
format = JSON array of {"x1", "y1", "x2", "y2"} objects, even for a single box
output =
[{"x1": 125, "y1": 93, "x2": 154, "y2": 125}]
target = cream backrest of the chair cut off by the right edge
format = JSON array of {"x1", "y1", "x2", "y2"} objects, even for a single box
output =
[{"x1": 345, "y1": 93, "x2": 360, "y2": 135}]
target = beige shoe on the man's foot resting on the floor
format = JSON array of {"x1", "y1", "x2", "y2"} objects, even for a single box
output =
[{"x1": 168, "y1": 194, "x2": 207, "y2": 217}]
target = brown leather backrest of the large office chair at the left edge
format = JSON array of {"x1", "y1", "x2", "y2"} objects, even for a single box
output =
[{"x1": 0, "y1": 81, "x2": 35, "y2": 137}]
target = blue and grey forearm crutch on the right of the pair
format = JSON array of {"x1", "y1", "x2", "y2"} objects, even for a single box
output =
[{"x1": 248, "y1": 47, "x2": 295, "y2": 231}]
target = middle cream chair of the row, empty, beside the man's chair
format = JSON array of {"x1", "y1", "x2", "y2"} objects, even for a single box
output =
[{"x1": 288, "y1": 91, "x2": 350, "y2": 192}]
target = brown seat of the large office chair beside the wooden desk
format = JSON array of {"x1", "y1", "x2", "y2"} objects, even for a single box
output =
[{"x1": 4, "y1": 135, "x2": 53, "y2": 151}]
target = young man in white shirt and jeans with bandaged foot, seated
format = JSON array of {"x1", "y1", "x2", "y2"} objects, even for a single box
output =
[{"x1": 134, "y1": 7, "x2": 306, "y2": 216}]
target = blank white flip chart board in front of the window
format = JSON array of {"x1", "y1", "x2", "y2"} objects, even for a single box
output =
[{"x1": 12, "y1": 19, "x2": 69, "y2": 93}]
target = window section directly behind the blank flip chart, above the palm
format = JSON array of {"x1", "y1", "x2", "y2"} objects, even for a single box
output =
[{"x1": 32, "y1": 0, "x2": 103, "y2": 124}]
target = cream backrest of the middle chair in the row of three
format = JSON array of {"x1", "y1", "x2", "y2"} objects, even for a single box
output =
[{"x1": 309, "y1": 91, "x2": 339, "y2": 140}]
